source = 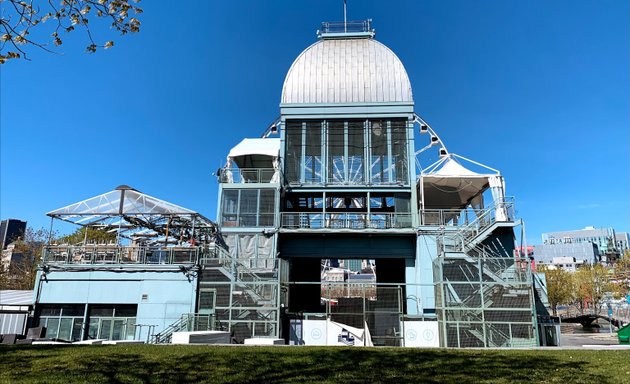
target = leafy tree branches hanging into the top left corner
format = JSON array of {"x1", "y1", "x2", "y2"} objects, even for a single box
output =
[{"x1": 0, "y1": 0, "x2": 142, "y2": 64}]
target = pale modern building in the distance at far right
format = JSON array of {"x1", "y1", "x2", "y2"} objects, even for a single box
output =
[{"x1": 542, "y1": 227, "x2": 621, "y2": 263}]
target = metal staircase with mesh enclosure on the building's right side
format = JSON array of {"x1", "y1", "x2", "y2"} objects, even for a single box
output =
[{"x1": 434, "y1": 198, "x2": 536, "y2": 347}]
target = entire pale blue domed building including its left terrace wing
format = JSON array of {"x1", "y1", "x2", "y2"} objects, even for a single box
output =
[{"x1": 36, "y1": 20, "x2": 538, "y2": 347}]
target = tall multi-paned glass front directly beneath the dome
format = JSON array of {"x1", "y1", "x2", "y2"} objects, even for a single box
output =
[{"x1": 285, "y1": 119, "x2": 409, "y2": 185}]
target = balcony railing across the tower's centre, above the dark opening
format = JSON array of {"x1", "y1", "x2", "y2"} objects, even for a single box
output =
[{"x1": 281, "y1": 212, "x2": 412, "y2": 229}]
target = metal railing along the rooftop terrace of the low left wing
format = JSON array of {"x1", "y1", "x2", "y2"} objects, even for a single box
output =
[{"x1": 42, "y1": 244, "x2": 216, "y2": 264}]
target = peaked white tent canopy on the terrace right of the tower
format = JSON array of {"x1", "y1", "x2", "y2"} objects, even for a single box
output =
[{"x1": 419, "y1": 154, "x2": 503, "y2": 210}]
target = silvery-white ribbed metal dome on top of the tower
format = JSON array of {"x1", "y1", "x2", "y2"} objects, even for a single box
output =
[{"x1": 281, "y1": 38, "x2": 413, "y2": 104}]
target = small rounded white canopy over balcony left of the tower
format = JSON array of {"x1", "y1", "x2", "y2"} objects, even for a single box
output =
[{"x1": 228, "y1": 138, "x2": 280, "y2": 168}]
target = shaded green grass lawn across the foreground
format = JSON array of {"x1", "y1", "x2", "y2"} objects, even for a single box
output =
[{"x1": 0, "y1": 345, "x2": 630, "y2": 384}]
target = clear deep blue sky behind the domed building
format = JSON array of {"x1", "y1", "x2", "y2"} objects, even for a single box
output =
[{"x1": 0, "y1": 0, "x2": 630, "y2": 244}]
